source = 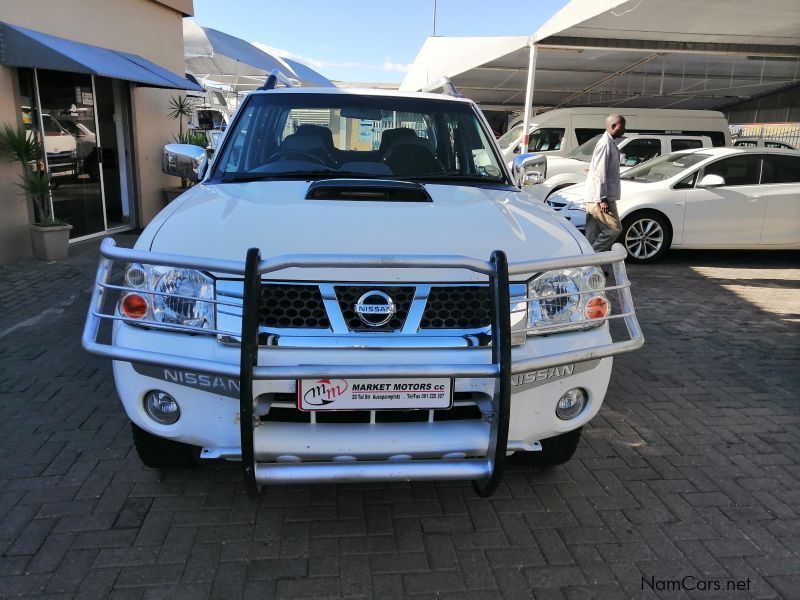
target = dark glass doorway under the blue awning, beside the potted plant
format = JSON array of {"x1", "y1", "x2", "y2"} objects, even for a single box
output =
[{"x1": 20, "y1": 69, "x2": 133, "y2": 241}]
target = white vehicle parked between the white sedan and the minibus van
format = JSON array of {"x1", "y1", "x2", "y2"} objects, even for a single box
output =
[{"x1": 525, "y1": 134, "x2": 713, "y2": 201}]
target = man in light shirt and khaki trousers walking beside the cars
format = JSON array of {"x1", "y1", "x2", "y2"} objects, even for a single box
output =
[{"x1": 586, "y1": 114, "x2": 625, "y2": 252}]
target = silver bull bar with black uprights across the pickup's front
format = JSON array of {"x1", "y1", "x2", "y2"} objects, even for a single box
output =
[{"x1": 82, "y1": 238, "x2": 644, "y2": 497}]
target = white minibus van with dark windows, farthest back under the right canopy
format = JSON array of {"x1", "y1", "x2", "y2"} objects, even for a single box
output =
[{"x1": 498, "y1": 107, "x2": 731, "y2": 162}]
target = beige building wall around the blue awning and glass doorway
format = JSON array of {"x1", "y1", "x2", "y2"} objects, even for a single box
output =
[{"x1": 0, "y1": 0, "x2": 192, "y2": 263}]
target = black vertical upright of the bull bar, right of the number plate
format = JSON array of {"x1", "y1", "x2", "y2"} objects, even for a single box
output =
[{"x1": 472, "y1": 250, "x2": 511, "y2": 498}]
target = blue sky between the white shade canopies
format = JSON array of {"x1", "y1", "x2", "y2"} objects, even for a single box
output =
[{"x1": 194, "y1": 0, "x2": 568, "y2": 83}]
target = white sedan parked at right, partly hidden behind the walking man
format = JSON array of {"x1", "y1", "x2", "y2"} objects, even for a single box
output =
[{"x1": 547, "y1": 148, "x2": 800, "y2": 263}]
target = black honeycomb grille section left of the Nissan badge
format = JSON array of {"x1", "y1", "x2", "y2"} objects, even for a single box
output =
[{"x1": 258, "y1": 283, "x2": 331, "y2": 329}]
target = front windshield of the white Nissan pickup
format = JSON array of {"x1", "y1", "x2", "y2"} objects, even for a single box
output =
[{"x1": 215, "y1": 92, "x2": 507, "y2": 183}]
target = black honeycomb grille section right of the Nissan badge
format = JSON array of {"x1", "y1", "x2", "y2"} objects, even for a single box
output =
[{"x1": 420, "y1": 285, "x2": 492, "y2": 329}]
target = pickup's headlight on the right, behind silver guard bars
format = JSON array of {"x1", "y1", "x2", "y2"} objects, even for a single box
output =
[{"x1": 528, "y1": 266, "x2": 611, "y2": 335}]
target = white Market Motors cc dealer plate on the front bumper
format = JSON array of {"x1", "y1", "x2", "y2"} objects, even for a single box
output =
[{"x1": 297, "y1": 378, "x2": 453, "y2": 410}]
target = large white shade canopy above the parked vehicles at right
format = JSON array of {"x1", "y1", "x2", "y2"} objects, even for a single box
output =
[{"x1": 400, "y1": 0, "x2": 800, "y2": 111}]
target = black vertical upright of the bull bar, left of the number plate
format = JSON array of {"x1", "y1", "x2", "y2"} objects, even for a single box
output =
[{"x1": 239, "y1": 248, "x2": 261, "y2": 492}]
